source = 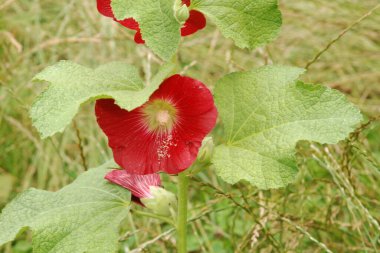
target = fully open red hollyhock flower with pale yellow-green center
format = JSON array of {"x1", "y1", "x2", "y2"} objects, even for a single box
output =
[{"x1": 95, "y1": 75, "x2": 218, "y2": 174}]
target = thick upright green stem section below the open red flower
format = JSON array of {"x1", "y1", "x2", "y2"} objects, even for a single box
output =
[{"x1": 177, "y1": 172, "x2": 189, "y2": 253}]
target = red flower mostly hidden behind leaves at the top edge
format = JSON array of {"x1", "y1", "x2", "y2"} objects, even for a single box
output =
[{"x1": 97, "y1": 0, "x2": 206, "y2": 44}]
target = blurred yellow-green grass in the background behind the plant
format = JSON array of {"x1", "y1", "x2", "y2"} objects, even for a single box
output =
[{"x1": 0, "y1": 0, "x2": 380, "y2": 253}]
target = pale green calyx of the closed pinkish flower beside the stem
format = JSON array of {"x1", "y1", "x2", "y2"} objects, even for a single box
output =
[{"x1": 140, "y1": 186, "x2": 177, "y2": 216}]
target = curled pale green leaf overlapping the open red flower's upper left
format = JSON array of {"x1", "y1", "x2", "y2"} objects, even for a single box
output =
[{"x1": 30, "y1": 61, "x2": 174, "y2": 138}]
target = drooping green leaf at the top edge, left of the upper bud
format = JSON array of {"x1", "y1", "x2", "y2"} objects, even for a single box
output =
[{"x1": 111, "y1": 0, "x2": 181, "y2": 61}]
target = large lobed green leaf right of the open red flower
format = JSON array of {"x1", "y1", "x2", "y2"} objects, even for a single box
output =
[{"x1": 213, "y1": 66, "x2": 362, "y2": 189}]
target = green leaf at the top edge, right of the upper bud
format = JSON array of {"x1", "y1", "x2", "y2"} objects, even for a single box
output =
[{"x1": 192, "y1": 0, "x2": 282, "y2": 49}]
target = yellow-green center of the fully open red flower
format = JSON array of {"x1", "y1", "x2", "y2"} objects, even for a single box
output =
[{"x1": 142, "y1": 99, "x2": 177, "y2": 133}]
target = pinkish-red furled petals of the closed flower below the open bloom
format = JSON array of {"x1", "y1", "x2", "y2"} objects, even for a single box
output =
[{"x1": 105, "y1": 170, "x2": 161, "y2": 199}]
